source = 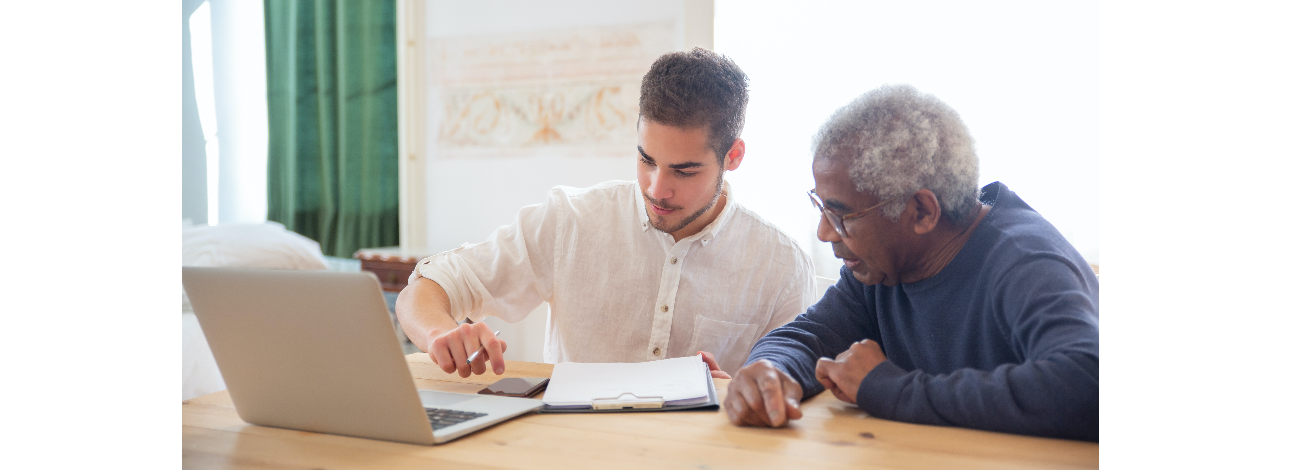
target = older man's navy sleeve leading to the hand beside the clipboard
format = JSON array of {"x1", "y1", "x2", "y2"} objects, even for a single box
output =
[{"x1": 745, "y1": 269, "x2": 880, "y2": 400}]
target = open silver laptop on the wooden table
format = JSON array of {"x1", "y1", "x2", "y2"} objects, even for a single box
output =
[{"x1": 181, "y1": 267, "x2": 542, "y2": 445}]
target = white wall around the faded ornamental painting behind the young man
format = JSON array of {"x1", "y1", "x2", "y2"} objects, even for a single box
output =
[{"x1": 424, "y1": 0, "x2": 683, "y2": 252}]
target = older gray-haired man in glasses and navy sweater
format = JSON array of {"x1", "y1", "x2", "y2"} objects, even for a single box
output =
[{"x1": 725, "y1": 86, "x2": 1101, "y2": 440}]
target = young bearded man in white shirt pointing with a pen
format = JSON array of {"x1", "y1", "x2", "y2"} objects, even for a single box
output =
[{"x1": 397, "y1": 48, "x2": 815, "y2": 377}]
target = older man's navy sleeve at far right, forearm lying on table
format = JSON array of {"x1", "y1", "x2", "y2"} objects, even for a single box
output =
[{"x1": 857, "y1": 256, "x2": 1101, "y2": 441}]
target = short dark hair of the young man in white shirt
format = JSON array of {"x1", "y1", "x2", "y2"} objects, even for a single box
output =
[{"x1": 640, "y1": 47, "x2": 749, "y2": 164}]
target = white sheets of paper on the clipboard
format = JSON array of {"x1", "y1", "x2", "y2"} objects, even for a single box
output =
[{"x1": 542, "y1": 356, "x2": 716, "y2": 410}]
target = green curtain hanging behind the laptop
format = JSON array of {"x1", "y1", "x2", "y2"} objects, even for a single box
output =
[{"x1": 265, "y1": 0, "x2": 398, "y2": 257}]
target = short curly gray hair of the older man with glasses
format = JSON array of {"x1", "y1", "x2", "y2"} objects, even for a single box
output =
[{"x1": 813, "y1": 84, "x2": 979, "y2": 223}]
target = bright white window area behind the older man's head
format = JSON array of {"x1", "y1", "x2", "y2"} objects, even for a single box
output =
[{"x1": 714, "y1": 0, "x2": 1101, "y2": 277}]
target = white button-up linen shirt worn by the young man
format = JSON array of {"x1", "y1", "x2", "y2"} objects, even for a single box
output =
[{"x1": 411, "y1": 182, "x2": 816, "y2": 375}]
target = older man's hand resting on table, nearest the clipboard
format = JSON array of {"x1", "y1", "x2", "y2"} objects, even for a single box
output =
[{"x1": 723, "y1": 360, "x2": 803, "y2": 427}]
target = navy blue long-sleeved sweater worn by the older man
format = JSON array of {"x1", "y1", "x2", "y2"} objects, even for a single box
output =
[{"x1": 749, "y1": 183, "x2": 1101, "y2": 441}]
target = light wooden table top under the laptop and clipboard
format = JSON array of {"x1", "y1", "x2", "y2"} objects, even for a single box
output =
[{"x1": 181, "y1": 353, "x2": 1101, "y2": 470}]
